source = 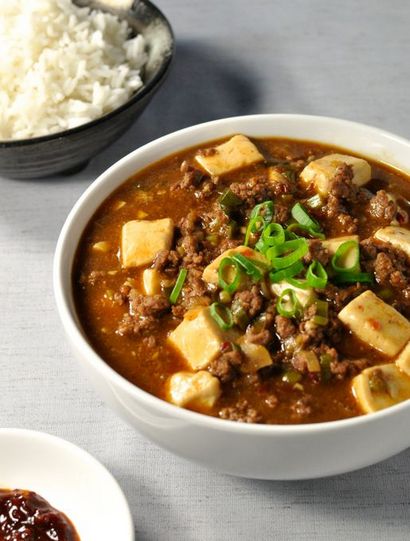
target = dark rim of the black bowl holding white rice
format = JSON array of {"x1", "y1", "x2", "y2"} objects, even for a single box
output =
[{"x1": 0, "y1": 0, "x2": 175, "y2": 148}]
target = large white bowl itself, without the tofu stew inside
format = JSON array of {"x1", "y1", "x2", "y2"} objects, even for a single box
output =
[{"x1": 54, "y1": 115, "x2": 410, "y2": 479}]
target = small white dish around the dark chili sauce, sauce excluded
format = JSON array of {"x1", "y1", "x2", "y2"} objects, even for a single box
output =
[{"x1": 0, "y1": 428, "x2": 134, "y2": 541}]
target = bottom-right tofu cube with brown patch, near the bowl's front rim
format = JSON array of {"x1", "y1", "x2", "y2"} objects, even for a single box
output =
[{"x1": 352, "y1": 364, "x2": 410, "y2": 413}]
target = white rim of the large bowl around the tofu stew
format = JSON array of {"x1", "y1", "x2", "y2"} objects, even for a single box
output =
[{"x1": 53, "y1": 113, "x2": 410, "y2": 437}]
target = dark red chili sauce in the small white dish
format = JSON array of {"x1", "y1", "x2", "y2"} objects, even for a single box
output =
[{"x1": 0, "y1": 489, "x2": 80, "y2": 541}]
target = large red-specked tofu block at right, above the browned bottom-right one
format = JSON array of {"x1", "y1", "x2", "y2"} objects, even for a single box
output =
[{"x1": 338, "y1": 290, "x2": 410, "y2": 357}]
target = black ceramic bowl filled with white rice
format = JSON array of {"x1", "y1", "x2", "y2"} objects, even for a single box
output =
[{"x1": 0, "y1": 0, "x2": 174, "y2": 179}]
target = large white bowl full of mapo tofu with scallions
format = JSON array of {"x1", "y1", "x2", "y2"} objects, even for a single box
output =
[{"x1": 54, "y1": 115, "x2": 410, "y2": 479}]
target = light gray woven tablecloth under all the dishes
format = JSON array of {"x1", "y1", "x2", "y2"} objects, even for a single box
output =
[{"x1": 0, "y1": 0, "x2": 410, "y2": 541}]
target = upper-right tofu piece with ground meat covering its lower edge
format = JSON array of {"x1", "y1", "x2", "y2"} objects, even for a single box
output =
[{"x1": 300, "y1": 154, "x2": 371, "y2": 195}]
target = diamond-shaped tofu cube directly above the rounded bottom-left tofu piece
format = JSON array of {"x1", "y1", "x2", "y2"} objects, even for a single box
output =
[{"x1": 168, "y1": 307, "x2": 237, "y2": 370}]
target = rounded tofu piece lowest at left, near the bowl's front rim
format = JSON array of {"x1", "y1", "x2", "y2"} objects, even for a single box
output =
[{"x1": 168, "y1": 370, "x2": 221, "y2": 409}]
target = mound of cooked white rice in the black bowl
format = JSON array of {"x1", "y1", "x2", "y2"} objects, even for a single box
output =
[{"x1": 0, "y1": 0, "x2": 147, "y2": 141}]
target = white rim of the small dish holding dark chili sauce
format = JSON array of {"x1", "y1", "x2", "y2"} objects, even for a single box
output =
[{"x1": 0, "y1": 428, "x2": 135, "y2": 541}]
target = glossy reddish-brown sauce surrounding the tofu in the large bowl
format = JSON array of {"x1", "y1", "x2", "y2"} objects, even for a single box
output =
[{"x1": 73, "y1": 138, "x2": 410, "y2": 424}]
